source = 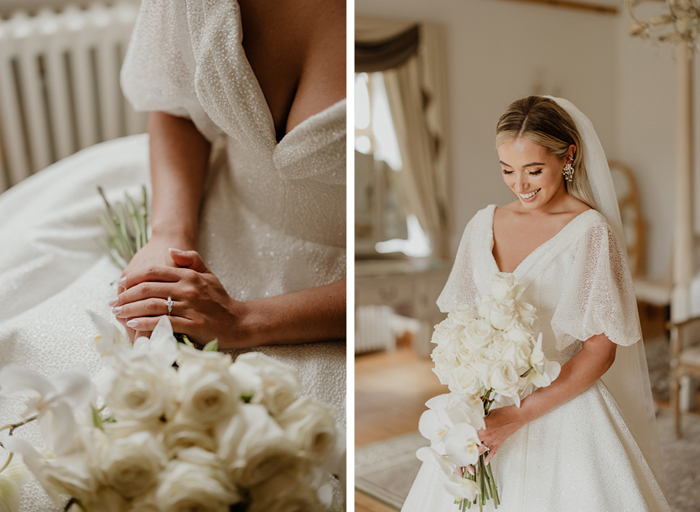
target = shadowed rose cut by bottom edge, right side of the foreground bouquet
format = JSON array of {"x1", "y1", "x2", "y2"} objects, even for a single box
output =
[{"x1": 248, "y1": 470, "x2": 324, "y2": 512}]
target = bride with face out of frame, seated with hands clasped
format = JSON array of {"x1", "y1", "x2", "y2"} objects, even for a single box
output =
[{"x1": 0, "y1": 0, "x2": 346, "y2": 510}]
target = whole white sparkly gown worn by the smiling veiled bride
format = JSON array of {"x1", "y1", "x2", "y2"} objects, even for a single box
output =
[{"x1": 402, "y1": 205, "x2": 670, "y2": 512}]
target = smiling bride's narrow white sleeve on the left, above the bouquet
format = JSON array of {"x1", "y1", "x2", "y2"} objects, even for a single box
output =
[{"x1": 437, "y1": 214, "x2": 478, "y2": 313}]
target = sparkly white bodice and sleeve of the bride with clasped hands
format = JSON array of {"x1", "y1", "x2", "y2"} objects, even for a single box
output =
[{"x1": 122, "y1": 0, "x2": 346, "y2": 300}]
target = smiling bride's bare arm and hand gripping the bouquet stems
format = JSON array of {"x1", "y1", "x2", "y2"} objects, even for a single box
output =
[{"x1": 479, "y1": 334, "x2": 617, "y2": 462}]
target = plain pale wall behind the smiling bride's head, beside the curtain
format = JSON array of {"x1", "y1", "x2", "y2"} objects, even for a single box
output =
[{"x1": 356, "y1": 0, "x2": 619, "y2": 264}]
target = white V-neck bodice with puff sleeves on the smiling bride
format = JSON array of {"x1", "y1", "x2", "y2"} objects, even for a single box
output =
[{"x1": 438, "y1": 205, "x2": 641, "y2": 364}]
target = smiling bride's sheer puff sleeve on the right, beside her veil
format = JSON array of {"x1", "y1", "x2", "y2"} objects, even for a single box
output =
[{"x1": 552, "y1": 222, "x2": 642, "y2": 350}]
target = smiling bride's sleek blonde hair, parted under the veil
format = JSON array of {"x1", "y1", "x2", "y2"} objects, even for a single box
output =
[{"x1": 496, "y1": 96, "x2": 595, "y2": 208}]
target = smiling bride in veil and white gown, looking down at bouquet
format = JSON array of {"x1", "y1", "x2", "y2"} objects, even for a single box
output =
[{"x1": 402, "y1": 96, "x2": 670, "y2": 512}]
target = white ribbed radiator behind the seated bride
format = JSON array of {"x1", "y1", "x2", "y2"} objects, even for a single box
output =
[{"x1": 0, "y1": 3, "x2": 146, "y2": 192}]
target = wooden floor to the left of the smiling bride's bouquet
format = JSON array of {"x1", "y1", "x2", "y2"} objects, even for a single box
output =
[{"x1": 355, "y1": 347, "x2": 440, "y2": 512}]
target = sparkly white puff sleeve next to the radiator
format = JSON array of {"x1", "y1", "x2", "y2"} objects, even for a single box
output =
[{"x1": 121, "y1": 0, "x2": 222, "y2": 141}]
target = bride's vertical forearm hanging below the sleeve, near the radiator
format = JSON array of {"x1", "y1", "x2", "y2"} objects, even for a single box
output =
[{"x1": 110, "y1": 112, "x2": 210, "y2": 339}]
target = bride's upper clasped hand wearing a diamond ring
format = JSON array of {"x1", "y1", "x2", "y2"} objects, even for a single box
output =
[{"x1": 112, "y1": 249, "x2": 254, "y2": 348}]
